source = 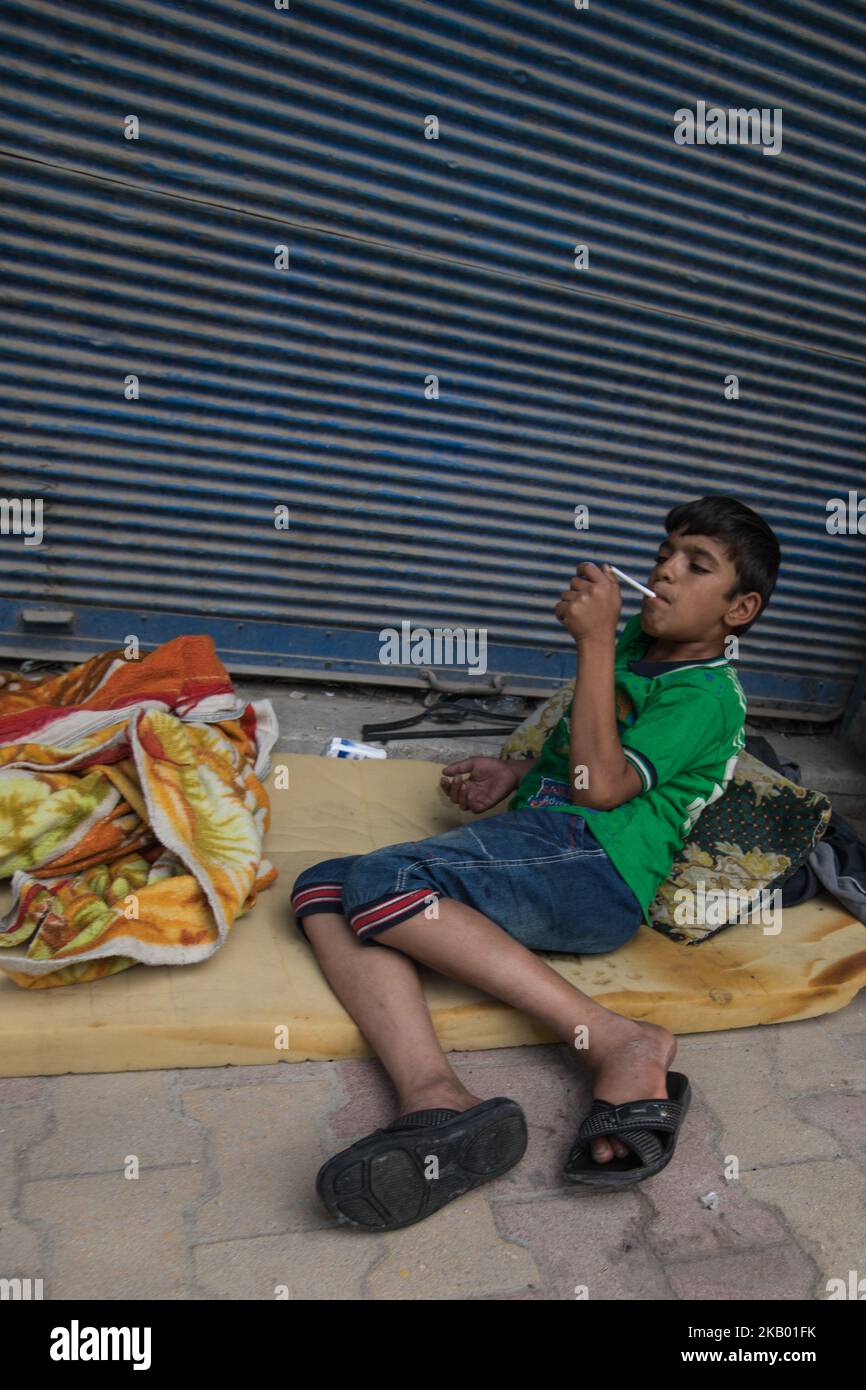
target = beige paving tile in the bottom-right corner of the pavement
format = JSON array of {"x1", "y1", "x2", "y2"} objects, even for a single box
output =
[{"x1": 742, "y1": 1158, "x2": 866, "y2": 1298}]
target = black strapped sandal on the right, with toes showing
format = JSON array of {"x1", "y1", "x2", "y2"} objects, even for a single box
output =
[{"x1": 563, "y1": 1072, "x2": 692, "y2": 1193}]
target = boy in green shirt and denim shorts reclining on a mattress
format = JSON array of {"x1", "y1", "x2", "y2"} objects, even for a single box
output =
[{"x1": 292, "y1": 495, "x2": 780, "y2": 1230}]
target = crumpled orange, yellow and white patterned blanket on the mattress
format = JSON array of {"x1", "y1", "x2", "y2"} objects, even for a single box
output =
[{"x1": 0, "y1": 637, "x2": 278, "y2": 988}]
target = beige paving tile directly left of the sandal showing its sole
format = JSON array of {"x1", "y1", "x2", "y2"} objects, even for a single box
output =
[{"x1": 181, "y1": 1077, "x2": 335, "y2": 1241}]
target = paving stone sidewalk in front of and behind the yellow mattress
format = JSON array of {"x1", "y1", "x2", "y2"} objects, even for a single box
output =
[{"x1": 0, "y1": 682, "x2": 866, "y2": 1301}]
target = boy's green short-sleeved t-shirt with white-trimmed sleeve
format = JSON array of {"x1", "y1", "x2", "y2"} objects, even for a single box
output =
[{"x1": 507, "y1": 613, "x2": 746, "y2": 917}]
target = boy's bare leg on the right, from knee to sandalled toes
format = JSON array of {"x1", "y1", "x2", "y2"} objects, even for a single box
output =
[{"x1": 378, "y1": 898, "x2": 677, "y2": 1162}]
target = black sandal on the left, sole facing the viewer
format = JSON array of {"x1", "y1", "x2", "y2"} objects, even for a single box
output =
[{"x1": 316, "y1": 1095, "x2": 527, "y2": 1230}]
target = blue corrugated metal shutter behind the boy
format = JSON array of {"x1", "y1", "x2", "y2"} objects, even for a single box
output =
[{"x1": 0, "y1": 0, "x2": 866, "y2": 713}]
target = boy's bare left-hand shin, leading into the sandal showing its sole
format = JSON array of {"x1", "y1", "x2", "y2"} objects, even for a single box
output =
[{"x1": 303, "y1": 912, "x2": 481, "y2": 1115}]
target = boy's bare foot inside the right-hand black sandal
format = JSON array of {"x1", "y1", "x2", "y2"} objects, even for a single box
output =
[{"x1": 589, "y1": 1020, "x2": 677, "y2": 1163}]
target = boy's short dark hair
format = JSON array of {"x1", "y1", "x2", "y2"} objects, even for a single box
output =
[{"x1": 664, "y1": 493, "x2": 781, "y2": 637}]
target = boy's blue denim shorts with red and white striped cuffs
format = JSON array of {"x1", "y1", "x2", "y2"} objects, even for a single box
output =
[{"x1": 292, "y1": 808, "x2": 644, "y2": 955}]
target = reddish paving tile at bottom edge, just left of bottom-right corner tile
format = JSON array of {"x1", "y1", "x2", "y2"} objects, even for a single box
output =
[{"x1": 664, "y1": 1241, "x2": 815, "y2": 1295}]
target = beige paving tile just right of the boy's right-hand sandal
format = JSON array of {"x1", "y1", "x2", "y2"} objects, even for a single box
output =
[{"x1": 674, "y1": 1027, "x2": 838, "y2": 1172}]
